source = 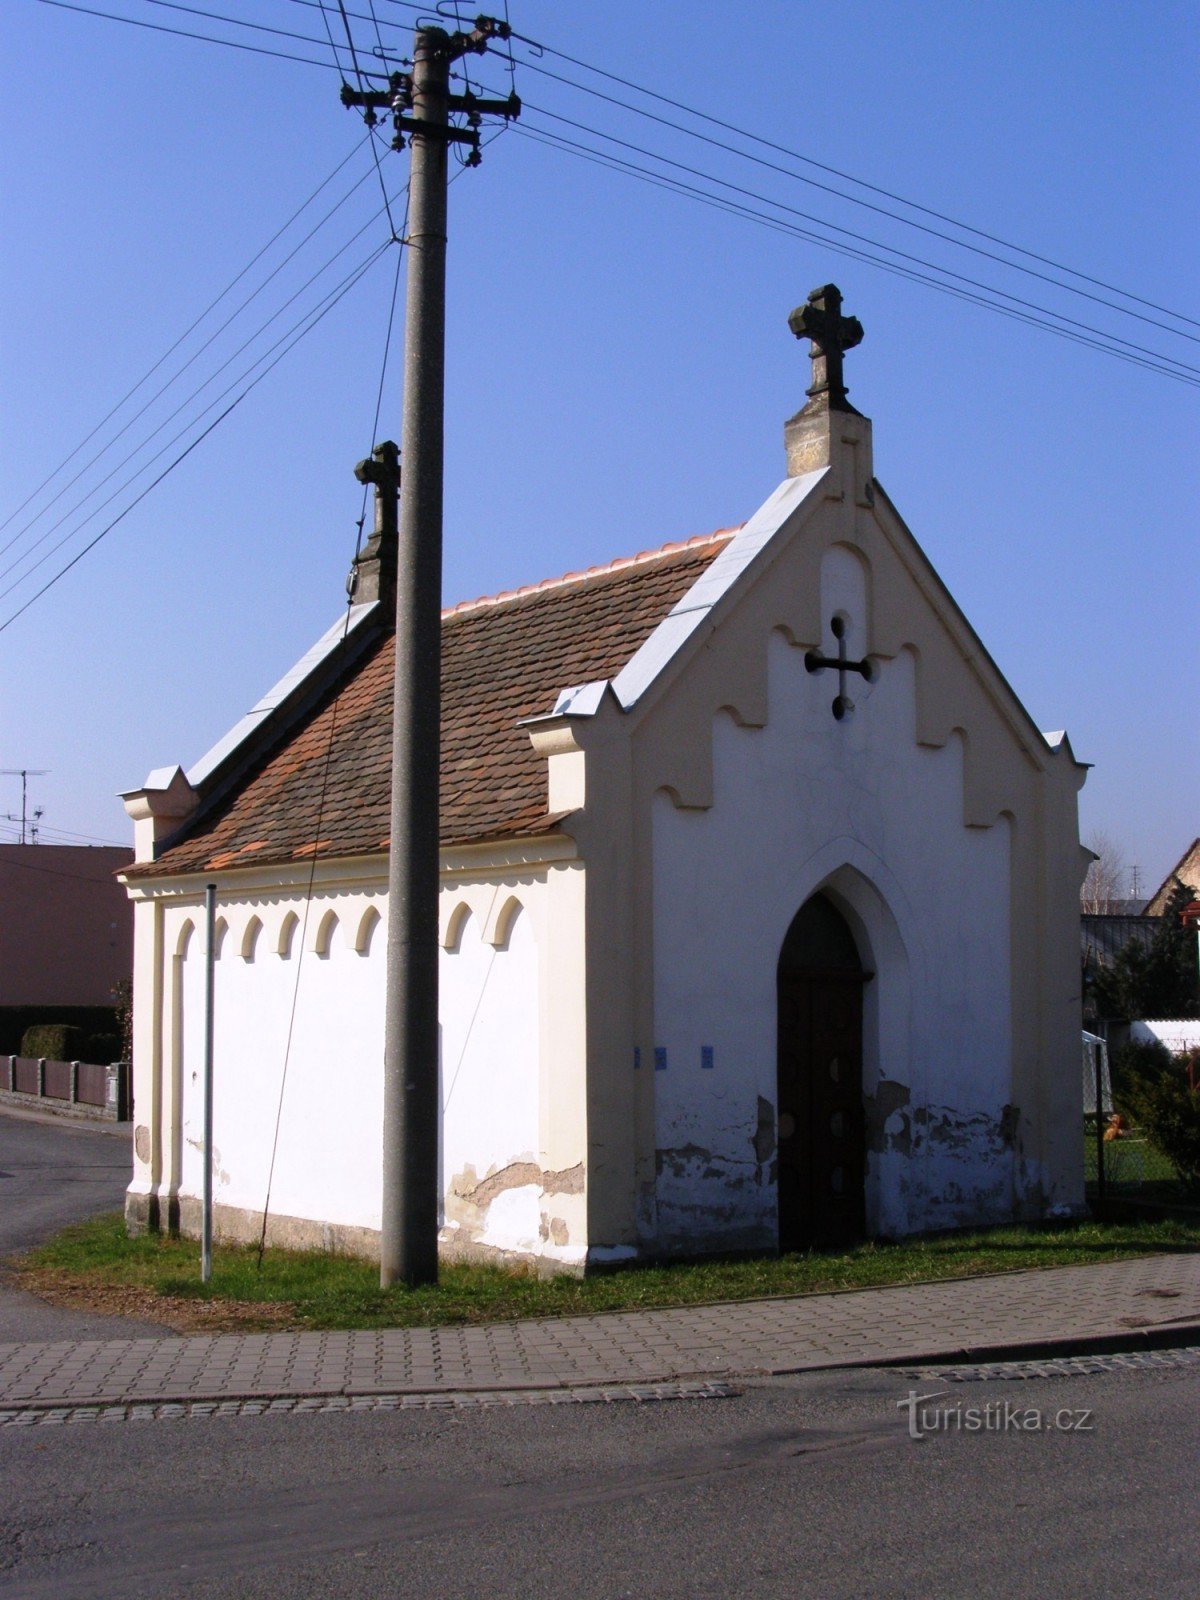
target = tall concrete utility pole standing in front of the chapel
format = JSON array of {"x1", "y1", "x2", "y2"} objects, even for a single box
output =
[{"x1": 379, "y1": 27, "x2": 450, "y2": 1288}]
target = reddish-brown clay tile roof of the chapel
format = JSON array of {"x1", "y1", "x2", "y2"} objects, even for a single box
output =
[{"x1": 140, "y1": 530, "x2": 733, "y2": 877}]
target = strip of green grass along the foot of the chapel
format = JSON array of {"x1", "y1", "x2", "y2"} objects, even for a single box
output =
[{"x1": 14, "y1": 1216, "x2": 1200, "y2": 1328}]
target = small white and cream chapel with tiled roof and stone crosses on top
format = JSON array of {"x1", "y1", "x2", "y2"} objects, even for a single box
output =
[{"x1": 123, "y1": 285, "x2": 1086, "y2": 1272}]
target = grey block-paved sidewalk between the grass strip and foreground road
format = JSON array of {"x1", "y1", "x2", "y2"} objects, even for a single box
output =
[{"x1": 0, "y1": 1254, "x2": 1200, "y2": 1411}]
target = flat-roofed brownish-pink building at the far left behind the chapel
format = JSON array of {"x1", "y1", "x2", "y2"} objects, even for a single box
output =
[{"x1": 0, "y1": 845, "x2": 133, "y2": 1008}]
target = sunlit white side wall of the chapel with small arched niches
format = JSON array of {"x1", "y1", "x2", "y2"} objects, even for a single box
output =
[{"x1": 126, "y1": 861, "x2": 586, "y2": 1264}]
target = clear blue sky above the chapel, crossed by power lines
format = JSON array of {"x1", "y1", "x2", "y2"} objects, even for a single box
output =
[{"x1": 0, "y1": 0, "x2": 1200, "y2": 886}]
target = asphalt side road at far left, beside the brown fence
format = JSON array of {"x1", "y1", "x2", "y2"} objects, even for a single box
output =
[{"x1": 0, "y1": 1107, "x2": 163, "y2": 1344}]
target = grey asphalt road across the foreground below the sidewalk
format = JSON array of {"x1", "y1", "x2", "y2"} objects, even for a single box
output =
[{"x1": 0, "y1": 1366, "x2": 1200, "y2": 1600}]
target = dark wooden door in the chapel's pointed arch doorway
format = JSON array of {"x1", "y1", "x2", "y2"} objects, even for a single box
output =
[{"x1": 776, "y1": 894, "x2": 870, "y2": 1251}]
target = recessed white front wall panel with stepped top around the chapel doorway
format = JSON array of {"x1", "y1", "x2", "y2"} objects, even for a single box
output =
[{"x1": 651, "y1": 627, "x2": 1014, "y2": 1248}]
